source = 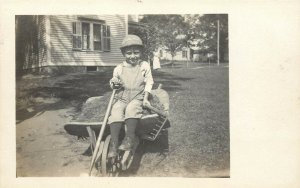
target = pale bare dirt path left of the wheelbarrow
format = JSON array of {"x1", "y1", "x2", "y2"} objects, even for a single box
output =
[{"x1": 17, "y1": 109, "x2": 90, "y2": 177}]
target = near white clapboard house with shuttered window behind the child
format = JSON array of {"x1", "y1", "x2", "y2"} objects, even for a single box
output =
[{"x1": 16, "y1": 15, "x2": 128, "y2": 73}]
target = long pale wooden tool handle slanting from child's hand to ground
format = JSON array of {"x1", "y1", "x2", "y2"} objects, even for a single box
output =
[{"x1": 89, "y1": 89, "x2": 116, "y2": 176}]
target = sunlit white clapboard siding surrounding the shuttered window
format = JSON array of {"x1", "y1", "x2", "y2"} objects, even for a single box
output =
[{"x1": 50, "y1": 15, "x2": 127, "y2": 66}]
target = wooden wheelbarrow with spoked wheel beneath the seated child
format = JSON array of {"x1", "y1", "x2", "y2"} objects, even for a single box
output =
[{"x1": 64, "y1": 85, "x2": 170, "y2": 176}]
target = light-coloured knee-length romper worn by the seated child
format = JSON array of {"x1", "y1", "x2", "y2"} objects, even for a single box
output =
[{"x1": 108, "y1": 62, "x2": 153, "y2": 124}]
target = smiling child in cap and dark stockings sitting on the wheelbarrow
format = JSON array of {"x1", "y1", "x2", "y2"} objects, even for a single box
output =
[{"x1": 108, "y1": 35, "x2": 153, "y2": 157}]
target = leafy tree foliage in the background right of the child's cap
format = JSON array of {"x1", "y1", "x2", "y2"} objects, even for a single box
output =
[{"x1": 130, "y1": 14, "x2": 228, "y2": 60}]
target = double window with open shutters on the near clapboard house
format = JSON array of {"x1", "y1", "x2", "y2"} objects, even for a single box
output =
[{"x1": 72, "y1": 22, "x2": 111, "y2": 51}]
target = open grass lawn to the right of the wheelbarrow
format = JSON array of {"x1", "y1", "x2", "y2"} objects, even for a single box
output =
[{"x1": 138, "y1": 63, "x2": 230, "y2": 177}]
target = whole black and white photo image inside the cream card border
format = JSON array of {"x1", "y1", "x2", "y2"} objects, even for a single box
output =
[{"x1": 15, "y1": 13, "x2": 230, "y2": 178}]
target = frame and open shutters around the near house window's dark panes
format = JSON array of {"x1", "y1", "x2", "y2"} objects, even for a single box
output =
[{"x1": 72, "y1": 20, "x2": 111, "y2": 52}]
